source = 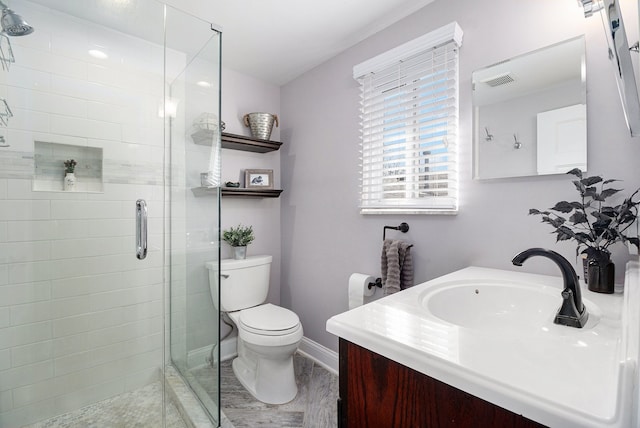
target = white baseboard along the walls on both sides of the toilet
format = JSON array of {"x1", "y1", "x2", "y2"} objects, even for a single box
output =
[{"x1": 187, "y1": 336, "x2": 338, "y2": 374}]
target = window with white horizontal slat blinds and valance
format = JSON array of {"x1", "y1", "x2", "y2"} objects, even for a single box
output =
[{"x1": 353, "y1": 22, "x2": 462, "y2": 214}]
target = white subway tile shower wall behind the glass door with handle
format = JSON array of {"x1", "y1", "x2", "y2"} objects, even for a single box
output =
[{"x1": 0, "y1": 0, "x2": 184, "y2": 428}]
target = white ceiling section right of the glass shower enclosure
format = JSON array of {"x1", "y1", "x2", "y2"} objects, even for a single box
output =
[{"x1": 214, "y1": 0, "x2": 434, "y2": 85}]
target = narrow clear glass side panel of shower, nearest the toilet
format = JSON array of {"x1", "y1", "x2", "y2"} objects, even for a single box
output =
[{"x1": 165, "y1": 8, "x2": 221, "y2": 421}]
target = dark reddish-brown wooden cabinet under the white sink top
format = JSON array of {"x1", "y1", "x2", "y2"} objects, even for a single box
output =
[{"x1": 338, "y1": 339, "x2": 544, "y2": 428}]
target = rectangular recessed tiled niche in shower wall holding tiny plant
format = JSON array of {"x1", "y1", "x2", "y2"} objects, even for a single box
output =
[{"x1": 33, "y1": 141, "x2": 104, "y2": 193}]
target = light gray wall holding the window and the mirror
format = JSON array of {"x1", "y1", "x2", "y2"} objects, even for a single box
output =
[{"x1": 280, "y1": 0, "x2": 640, "y2": 349}]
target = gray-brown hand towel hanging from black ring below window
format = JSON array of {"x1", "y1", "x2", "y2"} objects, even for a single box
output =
[{"x1": 381, "y1": 239, "x2": 413, "y2": 296}]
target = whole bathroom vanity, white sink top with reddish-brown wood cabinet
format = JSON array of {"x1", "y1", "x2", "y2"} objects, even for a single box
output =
[{"x1": 327, "y1": 262, "x2": 640, "y2": 428}]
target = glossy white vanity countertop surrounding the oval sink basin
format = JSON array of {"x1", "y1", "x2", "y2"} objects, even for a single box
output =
[{"x1": 327, "y1": 262, "x2": 640, "y2": 428}]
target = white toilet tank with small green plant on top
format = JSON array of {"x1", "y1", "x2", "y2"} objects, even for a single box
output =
[{"x1": 207, "y1": 256, "x2": 273, "y2": 312}]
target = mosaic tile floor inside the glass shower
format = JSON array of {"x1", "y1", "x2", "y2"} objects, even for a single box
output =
[{"x1": 23, "y1": 382, "x2": 186, "y2": 428}]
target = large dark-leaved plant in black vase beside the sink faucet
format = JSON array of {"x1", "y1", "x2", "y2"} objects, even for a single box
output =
[{"x1": 529, "y1": 168, "x2": 640, "y2": 293}]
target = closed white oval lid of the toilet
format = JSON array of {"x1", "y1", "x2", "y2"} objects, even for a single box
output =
[{"x1": 240, "y1": 303, "x2": 300, "y2": 335}]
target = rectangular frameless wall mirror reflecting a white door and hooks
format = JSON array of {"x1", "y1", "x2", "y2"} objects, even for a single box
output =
[{"x1": 471, "y1": 36, "x2": 587, "y2": 179}]
